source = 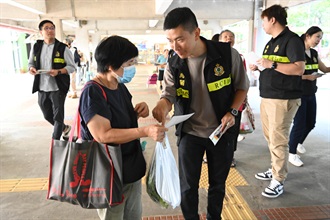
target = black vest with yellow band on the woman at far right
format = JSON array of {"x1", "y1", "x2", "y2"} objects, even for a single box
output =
[{"x1": 302, "y1": 48, "x2": 319, "y2": 95}]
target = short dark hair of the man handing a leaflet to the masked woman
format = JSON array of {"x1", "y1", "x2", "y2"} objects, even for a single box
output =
[{"x1": 163, "y1": 7, "x2": 198, "y2": 33}]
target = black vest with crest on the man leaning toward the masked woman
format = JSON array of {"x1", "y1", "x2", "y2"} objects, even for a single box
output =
[{"x1": 168, "y1": 37, "x2": 235, "y2": 137}]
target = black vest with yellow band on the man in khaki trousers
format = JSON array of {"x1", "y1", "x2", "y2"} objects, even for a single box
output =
[{"x1": 259, "y1": 28, "x2": 302, "y2": 99}]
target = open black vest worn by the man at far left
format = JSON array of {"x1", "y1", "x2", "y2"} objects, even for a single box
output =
[{"x1": 32, "y1": 39, "x2": 70, "y2": 93}]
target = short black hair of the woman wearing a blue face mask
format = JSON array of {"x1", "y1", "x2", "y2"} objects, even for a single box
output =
[{"x1": 95, "y1": 35, "x2": 139, "y2": 73}]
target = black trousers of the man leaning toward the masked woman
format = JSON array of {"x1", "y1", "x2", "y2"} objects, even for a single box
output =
[{"x1": 179, "y1": 134, "x2": 234, "y2": 220}]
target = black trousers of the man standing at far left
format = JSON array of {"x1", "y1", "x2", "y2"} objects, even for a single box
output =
[{"x1": 38, "y1": 90, "x2": 66, "y2": 140}]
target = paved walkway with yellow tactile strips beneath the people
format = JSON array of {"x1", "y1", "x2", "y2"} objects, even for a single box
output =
[{"x1": 0, "y1": 65, "x2": 330, "y2": 220}]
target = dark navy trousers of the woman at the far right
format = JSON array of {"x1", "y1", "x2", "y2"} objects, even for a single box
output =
[{"x1": 289, "y1": 94, "x2": 316, "y2": 154}]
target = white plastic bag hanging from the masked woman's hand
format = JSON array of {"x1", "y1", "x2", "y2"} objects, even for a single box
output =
[{"x1": 155, "y1": 133, "x2": 181, "y2": 209}]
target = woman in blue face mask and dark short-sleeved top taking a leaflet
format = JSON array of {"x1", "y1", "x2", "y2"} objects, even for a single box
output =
[{"x1": 79, "y1": 36, "x2": 167, "y2": 220}]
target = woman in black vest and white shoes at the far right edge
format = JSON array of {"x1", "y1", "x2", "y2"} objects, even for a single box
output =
[{"x1": 289, "y1": 26, "x2": 330, "y2": 167}]
